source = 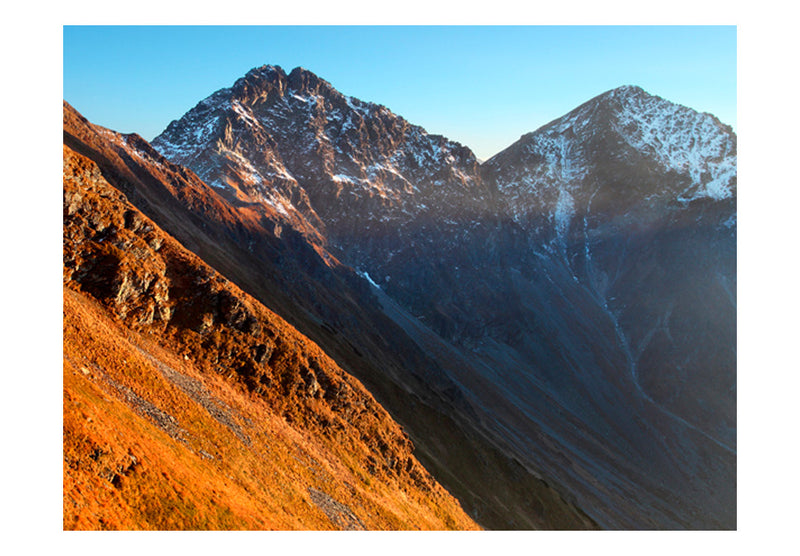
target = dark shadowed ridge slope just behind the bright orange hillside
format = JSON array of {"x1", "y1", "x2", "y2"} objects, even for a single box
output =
[{"x1": 64, "y1": 100, "x2": 594, "y2": 529}]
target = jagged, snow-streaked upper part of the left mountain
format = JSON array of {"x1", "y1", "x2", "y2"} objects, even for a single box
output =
[{"x1": 153, "y1": 65, "x2": 488, "y2": 251}]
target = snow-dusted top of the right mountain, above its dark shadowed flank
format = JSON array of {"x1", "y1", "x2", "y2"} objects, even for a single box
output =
[{"x1": 484, "y1": 85, "x2": 736, "y2": 210}]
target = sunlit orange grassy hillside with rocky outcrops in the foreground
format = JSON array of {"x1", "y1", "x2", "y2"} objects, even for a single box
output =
[{"x1": 63, "y1": 142, "x2": 477, "y2": 529}]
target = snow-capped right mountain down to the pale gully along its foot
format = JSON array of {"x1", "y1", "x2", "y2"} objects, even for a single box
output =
[{"x1": 485, "y1": 87, "x2": 736, "y2": 445}]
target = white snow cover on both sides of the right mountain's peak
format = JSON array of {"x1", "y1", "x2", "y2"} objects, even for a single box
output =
[{"x1": 500, "y1": 86, "x2": 737, "y2": 208}]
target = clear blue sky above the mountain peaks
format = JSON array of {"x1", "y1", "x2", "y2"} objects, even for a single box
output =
[{"x1": 63, "y1": 26, "x2": 736, "y2": 159}]
